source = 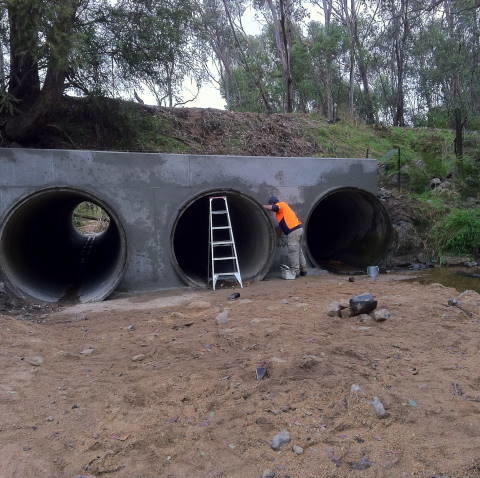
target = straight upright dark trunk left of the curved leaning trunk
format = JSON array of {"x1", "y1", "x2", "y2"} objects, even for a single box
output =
[{"x1": 7, "y1": 0, "x2": 40, "y2": 111}]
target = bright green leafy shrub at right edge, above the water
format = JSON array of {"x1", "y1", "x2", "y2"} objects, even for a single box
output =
[{"x1": 428, "y1": 208, "x2": 480, "y2": 262}]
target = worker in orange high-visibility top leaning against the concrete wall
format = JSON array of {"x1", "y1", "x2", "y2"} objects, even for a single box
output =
[{"x1": 263, "y1": 196, "x2": 307, "y2": 277}]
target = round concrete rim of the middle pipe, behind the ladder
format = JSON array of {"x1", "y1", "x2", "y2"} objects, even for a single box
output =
[{"x1": 170, "y1": 188, "x2": 276, "y2": 289}]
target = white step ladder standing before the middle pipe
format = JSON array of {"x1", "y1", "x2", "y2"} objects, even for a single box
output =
[{"x1": 208, "y1": 196, "x2": 243, "y2": 290}]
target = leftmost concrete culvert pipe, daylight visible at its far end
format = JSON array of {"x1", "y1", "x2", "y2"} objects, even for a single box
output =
[{"x1": 0, "y1": 188, "x2": 127, "y2": 302}]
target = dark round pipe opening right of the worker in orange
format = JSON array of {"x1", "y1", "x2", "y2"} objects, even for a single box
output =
[{"x1": 306, "y1": 188, "x2": 392, "y2": 269}]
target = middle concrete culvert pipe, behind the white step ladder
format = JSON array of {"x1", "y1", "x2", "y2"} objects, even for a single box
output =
[{"x1": 172, "y1": 191, "x2": 275, "y2": 287}]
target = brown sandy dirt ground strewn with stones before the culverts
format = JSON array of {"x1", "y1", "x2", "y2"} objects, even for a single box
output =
[{"x1": 0, "y1": 275, "x2": 480, "y2": 478}]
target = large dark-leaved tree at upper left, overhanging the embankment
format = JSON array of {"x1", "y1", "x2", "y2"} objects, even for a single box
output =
[{"x1": 3, "y1": 0, "x2": 195, "y2": 141}]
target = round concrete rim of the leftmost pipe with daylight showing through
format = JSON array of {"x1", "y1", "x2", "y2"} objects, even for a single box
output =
[{"x1": 0, "y1": 186, "x2": 128, "y2": 303}]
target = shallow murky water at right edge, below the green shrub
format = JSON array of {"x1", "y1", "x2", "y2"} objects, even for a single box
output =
[{"x1": 407, "y1": 267, "x2": 480, "y2": 293}]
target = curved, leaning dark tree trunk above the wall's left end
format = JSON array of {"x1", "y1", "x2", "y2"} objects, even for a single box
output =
[{"x1": 5, "y1": 0, "x2": 77, "y2": 142}]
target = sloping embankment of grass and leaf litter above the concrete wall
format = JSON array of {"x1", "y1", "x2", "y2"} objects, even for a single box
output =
[{"x1": 28, "y1": 99, "x2": 480, "y2": 260}]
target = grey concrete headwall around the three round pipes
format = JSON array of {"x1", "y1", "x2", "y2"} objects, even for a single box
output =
[{"x1": 0, "y1": 149, "x2": 377, "y2": 300}]
